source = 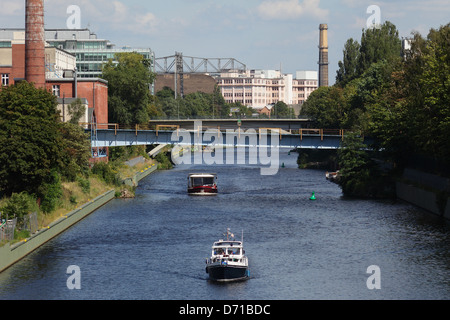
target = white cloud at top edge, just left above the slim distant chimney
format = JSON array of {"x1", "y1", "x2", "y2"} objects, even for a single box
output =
[{"x1": 258, "y1": 0, "x2": 328, "y2": 20}]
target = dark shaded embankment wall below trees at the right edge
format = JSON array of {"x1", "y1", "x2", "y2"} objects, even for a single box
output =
[{"x1": 396, "y1": 169, "x2": 450, "y2": 219}]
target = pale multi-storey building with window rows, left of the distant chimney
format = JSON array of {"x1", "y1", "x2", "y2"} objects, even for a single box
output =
[{"x1": 216, "y1": 70, "x2": 318, "y2": 114}]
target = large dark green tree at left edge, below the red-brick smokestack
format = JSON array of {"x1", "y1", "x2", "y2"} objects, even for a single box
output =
[{"x1": 0, "y1": 82, "x2": 62, "y2": 195}]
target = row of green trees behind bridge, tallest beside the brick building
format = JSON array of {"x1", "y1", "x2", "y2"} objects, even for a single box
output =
[{"x1": 103, "y1": 53, "x2": 294, "y2": 125}]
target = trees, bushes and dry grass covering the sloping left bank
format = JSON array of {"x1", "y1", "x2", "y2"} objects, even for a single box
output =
[{"x1": 0, "y1": 82, "x2": 160, "y2": 239}]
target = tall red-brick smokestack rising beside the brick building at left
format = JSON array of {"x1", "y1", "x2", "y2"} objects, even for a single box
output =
[{"x1": 25, "y1": 0, "x2": 45, "y2": 88}]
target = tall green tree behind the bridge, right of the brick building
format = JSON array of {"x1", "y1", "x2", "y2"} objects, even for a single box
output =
[{"x1": 103, "y1": 52, "x2": 155, "y2": 125}]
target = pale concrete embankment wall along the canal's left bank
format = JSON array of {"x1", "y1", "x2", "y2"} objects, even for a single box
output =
[{"x1": 0, "y1": 165, "x2": 157, "y2": 272}]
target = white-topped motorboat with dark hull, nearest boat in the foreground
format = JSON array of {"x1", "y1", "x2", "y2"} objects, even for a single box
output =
[{"x1": 206, "y1": 229, "x2": 250, "y2": 282}]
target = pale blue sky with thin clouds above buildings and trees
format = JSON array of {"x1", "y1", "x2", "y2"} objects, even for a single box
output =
[{"x1": 0, "y1": 0, "x2": 450, "y2": 84}]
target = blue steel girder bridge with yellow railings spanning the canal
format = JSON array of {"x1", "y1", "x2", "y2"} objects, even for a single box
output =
[{"x1": 92, "y1": 128, "x2": 356, "y2": 149}]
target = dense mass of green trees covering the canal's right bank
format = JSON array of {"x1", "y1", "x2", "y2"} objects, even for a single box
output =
[{"x1": 301, "y1": 22, "x2": 450, "y2": 196}]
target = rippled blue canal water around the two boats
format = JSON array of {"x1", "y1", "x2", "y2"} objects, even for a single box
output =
[{"x1": 0, "y1": 153, "x2": 450, "y2": 300}]
